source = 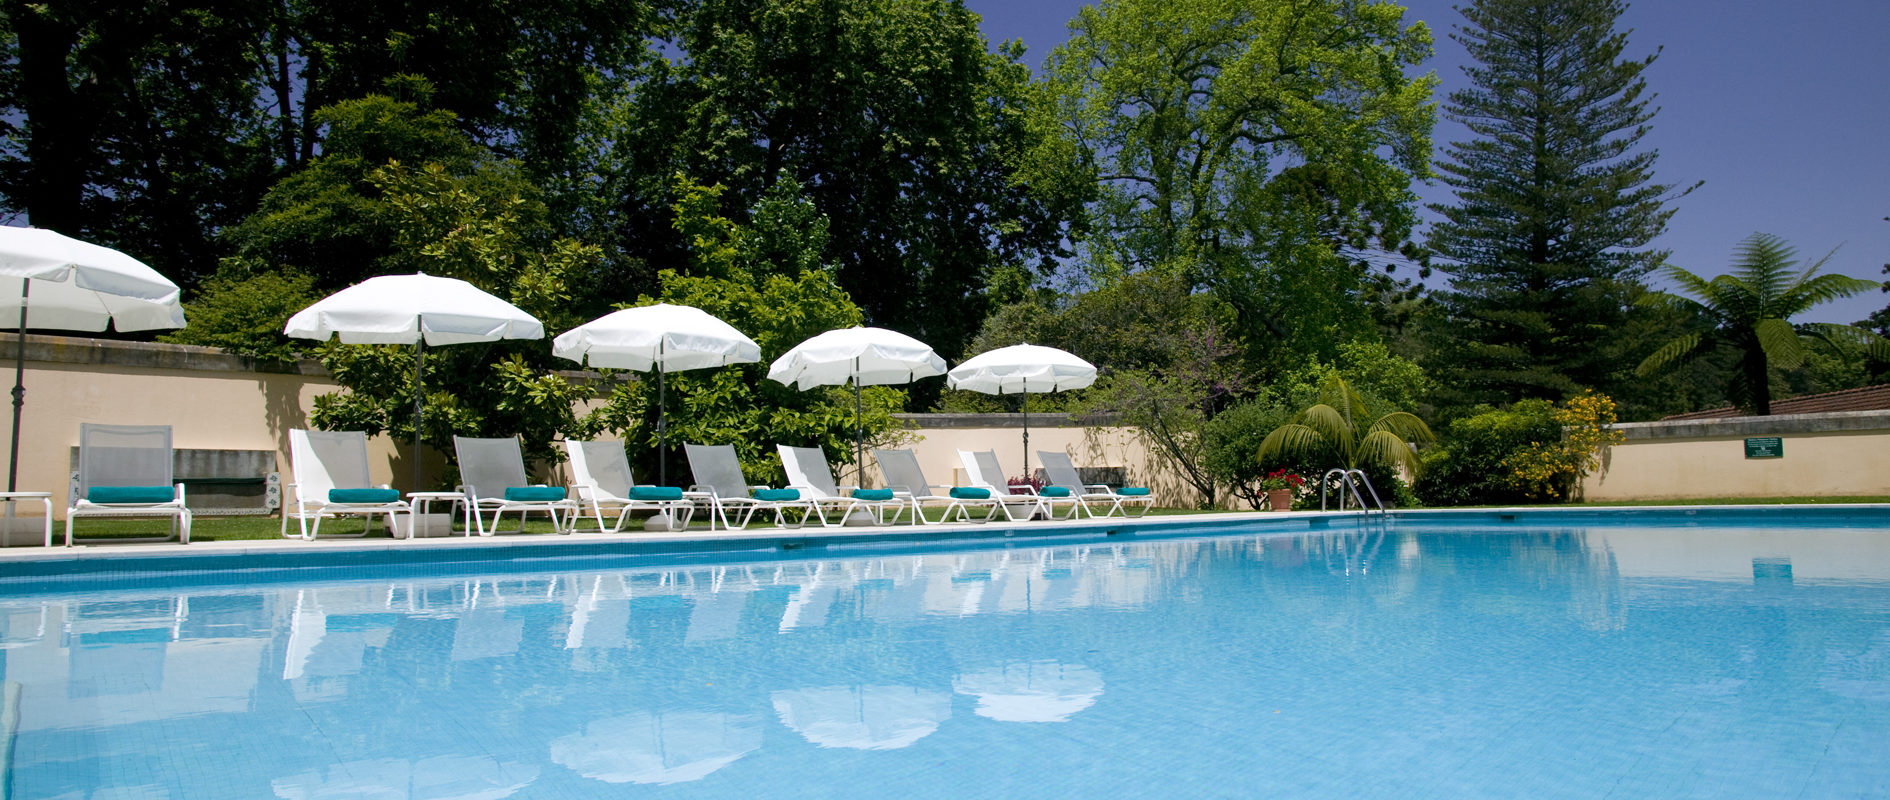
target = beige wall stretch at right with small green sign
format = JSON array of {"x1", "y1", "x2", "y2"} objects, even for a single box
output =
[{"x1": 1582, "y1": 410, "x2": 1890, "y2": 501}]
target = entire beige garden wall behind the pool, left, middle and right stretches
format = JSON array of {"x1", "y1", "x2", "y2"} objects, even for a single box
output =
[{"x1": 0, "y1": 335, "x2": 1890, "y2": 516}]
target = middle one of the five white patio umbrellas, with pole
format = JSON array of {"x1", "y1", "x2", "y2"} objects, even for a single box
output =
[{"x1": 552, "y1": 303, "x2": 762, "y2": 486}]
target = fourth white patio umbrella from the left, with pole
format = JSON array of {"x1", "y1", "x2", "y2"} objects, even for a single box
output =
[{"x1": 767, "y1": 327, "x2": 945, "y2": 482}]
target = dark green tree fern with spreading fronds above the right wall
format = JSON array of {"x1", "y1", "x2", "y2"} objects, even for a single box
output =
[{"x1": 1635, "y1": 233, "x2": 1890, "y2": 416}]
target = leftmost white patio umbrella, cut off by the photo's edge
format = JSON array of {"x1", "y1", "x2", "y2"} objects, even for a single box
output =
[{"x1": 0, "y1": 227, "x2": 183, "y2": 492}]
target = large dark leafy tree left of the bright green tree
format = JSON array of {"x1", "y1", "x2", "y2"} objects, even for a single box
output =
[{"x1": 588, "y1": 0, "x2": 1088, "y2": 368}]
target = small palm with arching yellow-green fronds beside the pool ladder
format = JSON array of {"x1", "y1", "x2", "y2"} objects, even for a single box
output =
[{"x1": 1259, "y1": 373, "x2": 1436, "y2": 475}]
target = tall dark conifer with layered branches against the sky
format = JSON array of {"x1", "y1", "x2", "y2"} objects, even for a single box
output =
[{"x1": 1429, "y1": 0, "x2": 1673, "y2": 405}]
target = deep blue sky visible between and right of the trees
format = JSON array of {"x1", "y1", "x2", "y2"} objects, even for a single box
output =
[{"x1": 964, "y1": 0, "x2": 1890, "y2": 322}]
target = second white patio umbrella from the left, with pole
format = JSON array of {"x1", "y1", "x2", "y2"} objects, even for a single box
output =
[{"x1": 282, "y1": 274, "x2": 544, "y2": 492}]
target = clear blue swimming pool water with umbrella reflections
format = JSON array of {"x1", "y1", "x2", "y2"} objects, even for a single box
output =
[{"x1": 0, "y1": 522, "x2": 1890, "y2": 800}]
